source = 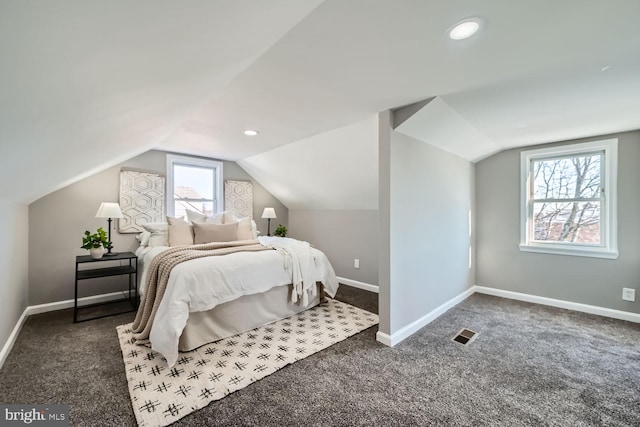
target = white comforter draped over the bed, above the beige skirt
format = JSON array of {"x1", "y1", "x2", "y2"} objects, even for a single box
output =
[{"x1": 136, "y1": 237, "x2": 338, "y2": 366}]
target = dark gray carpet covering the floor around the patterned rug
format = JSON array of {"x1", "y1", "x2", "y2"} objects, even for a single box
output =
[{"x1": 0, "y1": 286, "x2": 640, "y2": 426}]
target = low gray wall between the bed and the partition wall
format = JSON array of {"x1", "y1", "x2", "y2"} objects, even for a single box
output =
[{"x1": 288, "y1": 210, "x2": 378, "y2": 285}]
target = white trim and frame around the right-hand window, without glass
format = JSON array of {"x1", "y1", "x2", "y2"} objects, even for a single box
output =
[{"x1": 519, "y1": 139, "x2": 618, "y2": 259}]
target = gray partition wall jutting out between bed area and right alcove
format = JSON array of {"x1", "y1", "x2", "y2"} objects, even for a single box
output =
[{"x1": 379, "y1": 112, "x2": 475, "y2": 335}]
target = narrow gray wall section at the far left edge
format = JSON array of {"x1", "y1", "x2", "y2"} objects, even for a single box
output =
[{"x1": 0, "y1": 199, "x2": 29, "y2": 358}]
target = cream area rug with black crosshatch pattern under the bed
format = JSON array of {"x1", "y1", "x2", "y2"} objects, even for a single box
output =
[{"x1": 116, "y1": 299, "x2": 378, "y2": 427}]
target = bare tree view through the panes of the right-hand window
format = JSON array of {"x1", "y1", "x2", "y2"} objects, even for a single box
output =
[{"x1": 531, "y1": 153, "x2": 604, "y2": 245}]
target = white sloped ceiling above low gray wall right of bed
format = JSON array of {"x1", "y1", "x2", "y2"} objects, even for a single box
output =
[{"x1": 238, "y1": 116, "x2": 378, "y2": 210}]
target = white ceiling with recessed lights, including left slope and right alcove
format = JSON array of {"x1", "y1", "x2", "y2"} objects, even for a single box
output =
[{"x1": 0, "y1": 0, "x2": 640, "y2": 208}]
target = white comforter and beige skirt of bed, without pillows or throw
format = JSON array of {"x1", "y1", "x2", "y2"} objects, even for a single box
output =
[{"x1": 136, "y1": 237, "x2": 338, "y2": 366}]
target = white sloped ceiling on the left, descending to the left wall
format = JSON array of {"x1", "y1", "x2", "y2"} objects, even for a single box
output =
[{"x1": 0, "y1": 0, "x2": 321, "y2": 203}]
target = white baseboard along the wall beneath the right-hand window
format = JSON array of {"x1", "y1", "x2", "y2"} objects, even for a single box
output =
[{"x1": 472, "y1": 286, "x2": 640, "y2": 323}]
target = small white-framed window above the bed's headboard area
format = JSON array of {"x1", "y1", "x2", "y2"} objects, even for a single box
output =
[{"x1": 167, "y1": 155, "x2": 223, "y2": 218}]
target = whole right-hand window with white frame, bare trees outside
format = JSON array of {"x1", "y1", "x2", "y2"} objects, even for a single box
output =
[{"x1": 520, "y1": 139, "x2": 618, "y2": 258}]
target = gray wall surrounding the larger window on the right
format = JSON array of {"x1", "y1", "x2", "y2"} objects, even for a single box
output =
[{"x1": 476, "y1": 131, "x2": 640, "y2": 313}]
